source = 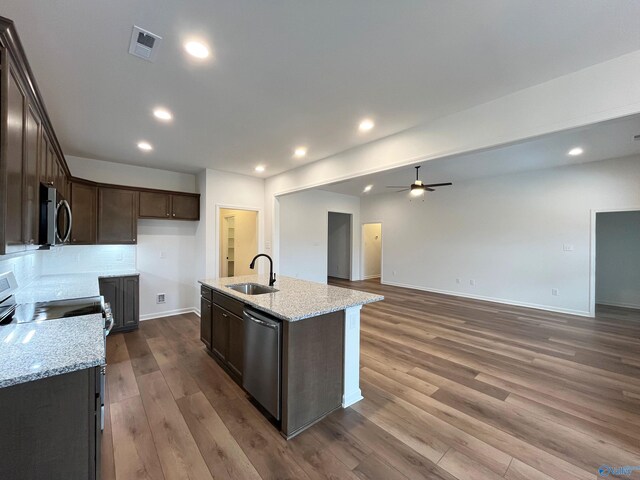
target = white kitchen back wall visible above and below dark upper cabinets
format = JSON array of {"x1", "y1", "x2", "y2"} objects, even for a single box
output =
[{"x1": 62, "y1": 157, "x2": 199, "y2": 319}]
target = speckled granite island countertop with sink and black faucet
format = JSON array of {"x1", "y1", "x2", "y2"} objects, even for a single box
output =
[{"x1": 200, "y1": 275, "x2": 384, "y2": 322}]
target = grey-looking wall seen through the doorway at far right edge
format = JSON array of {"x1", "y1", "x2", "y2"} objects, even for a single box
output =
[{"x1": 596, "y1": 211, "x2": 640, "y2": 308}]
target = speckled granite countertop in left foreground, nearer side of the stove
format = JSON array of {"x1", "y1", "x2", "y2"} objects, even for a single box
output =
[{"x1": 0, "y1": 314, "x2": 105, "y2": 388}]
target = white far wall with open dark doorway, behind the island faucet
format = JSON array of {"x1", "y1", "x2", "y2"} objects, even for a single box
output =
[{"x1": 278, "y1": 190, "x2": 360, "y2": 283}]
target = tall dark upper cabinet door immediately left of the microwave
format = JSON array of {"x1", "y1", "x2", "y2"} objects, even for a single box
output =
[{"x1": 23, "y1": 105, "x2": 40, "y2": 245}]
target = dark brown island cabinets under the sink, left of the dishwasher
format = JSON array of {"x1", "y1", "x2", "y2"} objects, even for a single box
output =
[{"x1": 200, "y1": 287, "x2": 244, "y2": 385}]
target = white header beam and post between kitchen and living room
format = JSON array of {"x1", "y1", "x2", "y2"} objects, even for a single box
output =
[{"x1": 265, "y1": 50, "x2": 640, "y2": 272}]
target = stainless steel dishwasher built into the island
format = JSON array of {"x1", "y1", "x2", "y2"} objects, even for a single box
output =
[{"x1": 242, "y1": 307, "x2": 282, "y2": 420}]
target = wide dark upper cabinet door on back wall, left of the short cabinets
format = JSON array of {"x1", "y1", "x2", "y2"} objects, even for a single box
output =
[{"x1": 98, "y1": 187, "x2": 138, "y2": 244}]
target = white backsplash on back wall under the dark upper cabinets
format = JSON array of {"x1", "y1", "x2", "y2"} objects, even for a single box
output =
[{"x1": 41, "y1": 245, "x2": 136, "y2": 275}]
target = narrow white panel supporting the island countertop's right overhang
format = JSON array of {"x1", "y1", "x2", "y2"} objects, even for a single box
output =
[{"x1": 342, "y1": 305, "x2": 363, "y2": 408}]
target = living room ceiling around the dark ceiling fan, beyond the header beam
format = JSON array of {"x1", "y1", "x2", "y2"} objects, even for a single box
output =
[{"x1": 318, "y1": 115, "x2": 640, "y2": 196}]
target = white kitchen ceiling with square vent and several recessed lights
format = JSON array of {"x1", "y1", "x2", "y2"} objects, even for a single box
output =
[{"x1": 0, "y1": 0, "x2": 640, "y2": 176}]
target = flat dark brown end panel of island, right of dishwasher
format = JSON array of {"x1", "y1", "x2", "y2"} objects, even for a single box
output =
[{"x1": 282, "y1": 311, "x2": 344, "y2": 438}]
